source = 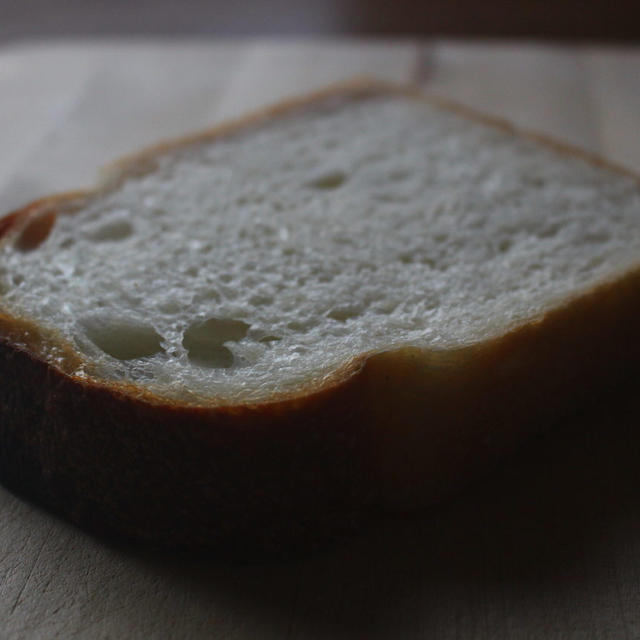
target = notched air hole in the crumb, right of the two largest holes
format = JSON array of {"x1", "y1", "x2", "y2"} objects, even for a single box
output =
[{"x1": 182, "y1": 318, "x2": 251, "y2": 369}]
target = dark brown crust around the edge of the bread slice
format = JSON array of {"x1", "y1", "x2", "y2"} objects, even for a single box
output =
[{"x1": 0, "y1": 82, "x2": 640, "y2": 553}]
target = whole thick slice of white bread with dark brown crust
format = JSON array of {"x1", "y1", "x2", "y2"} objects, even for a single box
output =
[{"x1": 0, "y1": 85, "x2": 640, "y2": 548}]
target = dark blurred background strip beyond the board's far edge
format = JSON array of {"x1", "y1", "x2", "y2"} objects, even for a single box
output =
[{"x1": 0, "y1": 0, "x2": 640, "y2": 43}]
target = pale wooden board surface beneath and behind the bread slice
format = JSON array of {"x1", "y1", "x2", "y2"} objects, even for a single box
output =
[{"x1": 0, "y1": 41, "x2": 640, "y2": 640}]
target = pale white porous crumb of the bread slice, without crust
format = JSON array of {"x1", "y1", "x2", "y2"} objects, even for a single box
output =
[{"x1": 0, "y1": 95, "x2": 640, "y2": 402}]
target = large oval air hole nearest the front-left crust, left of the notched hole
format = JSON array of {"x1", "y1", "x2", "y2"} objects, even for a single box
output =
[{"x1": 81, "y1": 315, "x2": 163, "y2": 360}]
